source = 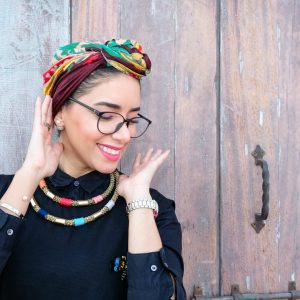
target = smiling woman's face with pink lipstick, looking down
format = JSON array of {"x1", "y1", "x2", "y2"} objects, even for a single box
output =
[{"x1": 55, "y1": 74, "x2": 141, "y2": 177}]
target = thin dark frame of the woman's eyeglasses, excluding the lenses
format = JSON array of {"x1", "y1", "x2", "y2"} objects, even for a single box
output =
[{"x1": 68, "y1": 96, "x2": 152, "y2": 139}]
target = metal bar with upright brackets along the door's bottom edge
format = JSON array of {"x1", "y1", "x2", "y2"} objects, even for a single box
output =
[{"x1": 192, "y1": 281, "x2": 300, "y2": 300}]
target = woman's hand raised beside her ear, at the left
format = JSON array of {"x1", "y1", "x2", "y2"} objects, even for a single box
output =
[{"x1": 22, "y1": 96, "x2": 63, "y2": 181}]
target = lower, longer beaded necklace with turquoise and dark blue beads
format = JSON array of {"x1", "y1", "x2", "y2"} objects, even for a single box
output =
[{"x1": 30, "y1": 172, "x2": 119, "y2": 226}]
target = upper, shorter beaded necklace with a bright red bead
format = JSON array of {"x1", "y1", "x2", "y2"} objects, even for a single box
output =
[{"x1": 39, "y1": 171, "x2": 118, "y2": 206}]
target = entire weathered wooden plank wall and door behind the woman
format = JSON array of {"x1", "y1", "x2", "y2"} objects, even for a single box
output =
[{"x1": 0, "y1": 0, "x2": 300, "y2": 298}]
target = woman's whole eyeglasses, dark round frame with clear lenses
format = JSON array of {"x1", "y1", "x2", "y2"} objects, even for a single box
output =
[{"x1": 69, "y1": 97, "x2": 152, "y2": 138}]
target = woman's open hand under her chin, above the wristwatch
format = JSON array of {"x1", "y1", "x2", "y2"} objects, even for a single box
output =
[{"x1": 118, "y1": 148, "x2": 170, "y2": 202}]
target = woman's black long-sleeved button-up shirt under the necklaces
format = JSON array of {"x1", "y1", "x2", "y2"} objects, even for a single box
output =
[{"x1": 0, "y1": 169, "x2": 186, "y2": 300}]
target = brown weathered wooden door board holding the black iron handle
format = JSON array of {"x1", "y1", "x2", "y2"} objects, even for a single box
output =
[{"x1": 220, "y1": 0, "x2": 300, "y2": 294}]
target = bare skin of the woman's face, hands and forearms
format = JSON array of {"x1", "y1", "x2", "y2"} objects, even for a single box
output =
[{"x1": 1, "y1": 74, "x2": 169, "y2": 253}]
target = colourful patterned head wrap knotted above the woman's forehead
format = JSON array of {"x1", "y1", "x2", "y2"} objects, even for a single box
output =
[{"x1": 43, "y1": 39, "x2": 151, "y2": 116}]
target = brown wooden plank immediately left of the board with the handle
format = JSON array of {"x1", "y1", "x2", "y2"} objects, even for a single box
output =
[{"x1": 174, "y1": 0, "x2": 219, "y2": 299}]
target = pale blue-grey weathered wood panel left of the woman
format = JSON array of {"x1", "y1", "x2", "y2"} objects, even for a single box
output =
[{"x1": 0, "y1": 0, "x2": 69, "y2": 173}]
